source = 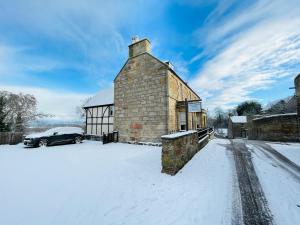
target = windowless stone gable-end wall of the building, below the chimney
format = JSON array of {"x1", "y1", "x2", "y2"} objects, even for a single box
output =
[{"x1": 114, "y1": 53, "x2": 168, "y2": 142}]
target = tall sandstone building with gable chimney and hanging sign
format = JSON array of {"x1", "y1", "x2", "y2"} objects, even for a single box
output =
[{"x1": 84, "y1": 39, "x2": 206, "y2": 142}]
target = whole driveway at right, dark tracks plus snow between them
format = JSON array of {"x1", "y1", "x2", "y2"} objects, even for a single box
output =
[{"x1": 227, "y1": 139, "x2": 300, "y2": 225}]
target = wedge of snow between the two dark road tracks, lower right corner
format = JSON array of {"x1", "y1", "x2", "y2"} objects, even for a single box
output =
[{"x1": 247, "y1": 145, "x2": 300, "y2": 225}]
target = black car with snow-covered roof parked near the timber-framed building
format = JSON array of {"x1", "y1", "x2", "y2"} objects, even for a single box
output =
[{"x1": 24, "y1": 127, "x2": 84, "y2": 147}]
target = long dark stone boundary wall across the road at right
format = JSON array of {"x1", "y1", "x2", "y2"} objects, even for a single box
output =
[{"x1": 248, "y1": 113, "x2": 300, "y2": 142}]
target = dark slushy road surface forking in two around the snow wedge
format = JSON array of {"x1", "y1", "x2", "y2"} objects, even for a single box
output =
[{"x1": 227, "y1": 139, "x2": 300, "y2": 225}]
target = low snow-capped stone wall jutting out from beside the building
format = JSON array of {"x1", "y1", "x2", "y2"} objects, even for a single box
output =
[{"x1": 161, "y1": 131, "x2": 213, "y2": 175}]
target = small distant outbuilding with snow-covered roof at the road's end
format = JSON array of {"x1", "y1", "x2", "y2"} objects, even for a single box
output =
[{"x1": 228, "y1": 116, "x2": 247, "y2": 138}]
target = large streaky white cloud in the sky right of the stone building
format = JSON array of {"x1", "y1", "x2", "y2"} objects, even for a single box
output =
[{"x1": 191, "y1": 1, "x2": 300, "y2": 108}]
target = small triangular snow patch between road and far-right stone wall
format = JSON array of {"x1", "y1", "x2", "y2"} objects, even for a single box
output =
[{"x1": 268, "y1": 143, "x2": 300, "y2": 165}]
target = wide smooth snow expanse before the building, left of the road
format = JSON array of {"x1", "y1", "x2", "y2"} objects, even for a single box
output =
[{"x1": 0, "y1": 139, "x2": 236, "y2": 225}]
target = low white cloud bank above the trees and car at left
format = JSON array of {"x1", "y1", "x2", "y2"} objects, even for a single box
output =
[{"x1": 0, "y1": 85, "x2": 92, "y2": 121}]
